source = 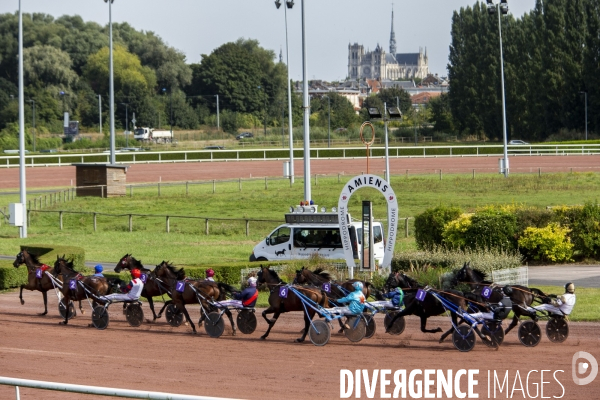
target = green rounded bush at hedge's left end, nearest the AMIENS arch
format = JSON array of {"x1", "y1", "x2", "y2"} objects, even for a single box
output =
[{"x1": 415, "y1": 206, "x2": 462, "y2": 250}]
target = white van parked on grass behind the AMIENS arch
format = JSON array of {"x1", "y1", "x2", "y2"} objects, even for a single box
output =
[{"x1": 250, "y1": 206, "x2": 385, "y2": 264}]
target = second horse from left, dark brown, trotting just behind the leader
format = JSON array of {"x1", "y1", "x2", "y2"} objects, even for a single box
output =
[{"x1": 54, "y1": 256, "x2": 113, "y2": 325}]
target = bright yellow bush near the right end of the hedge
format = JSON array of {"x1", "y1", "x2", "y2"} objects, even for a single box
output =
[{"x1": 519, "y1": 223, "x2": 573, "y2": 262}]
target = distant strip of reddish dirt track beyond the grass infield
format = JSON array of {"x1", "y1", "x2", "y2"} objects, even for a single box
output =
[{"x1": 0, "y1": 155, "x2": 600, "y2": 189}]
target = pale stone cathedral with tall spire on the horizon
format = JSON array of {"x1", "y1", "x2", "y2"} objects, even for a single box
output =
[{"x1": 348, "y1": 10, "x2": 429, "y2": 80}]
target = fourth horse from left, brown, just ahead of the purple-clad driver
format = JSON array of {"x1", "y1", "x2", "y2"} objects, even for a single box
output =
[{"x1": 154, "y1": 261, "x2": 236, "y2": 336}]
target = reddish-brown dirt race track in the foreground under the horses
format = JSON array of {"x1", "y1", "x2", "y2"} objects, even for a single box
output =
[{"x1": 0, "y1": 292, "x2": 600, "y2": 400}]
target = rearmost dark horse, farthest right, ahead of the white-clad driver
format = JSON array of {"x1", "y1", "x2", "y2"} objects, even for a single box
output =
[{"x1": 453, "y1": 263, "x2": 547, "y2": 334}]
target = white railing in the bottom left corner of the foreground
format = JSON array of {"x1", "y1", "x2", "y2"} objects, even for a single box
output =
[{"x1": 0, "y1": 376, "x2": 241, "y2": 400}]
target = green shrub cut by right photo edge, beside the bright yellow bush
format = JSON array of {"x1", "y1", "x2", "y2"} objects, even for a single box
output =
[{"x1": 571, "y1": 201, "x2": 600, "y2": 258}]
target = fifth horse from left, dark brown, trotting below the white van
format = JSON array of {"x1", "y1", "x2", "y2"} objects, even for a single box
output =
[{"x1": 256, "y1": 265, "x2": 328, "y2": 343}]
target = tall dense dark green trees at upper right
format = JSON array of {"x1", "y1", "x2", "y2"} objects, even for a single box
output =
[{"x1": 448, "y1": 0, "x2": 600, "y2": 141}]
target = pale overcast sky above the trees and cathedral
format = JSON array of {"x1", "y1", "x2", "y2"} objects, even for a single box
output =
[{"x1": 0, "y1": 0, "x2": 535, "y2": 80}]
